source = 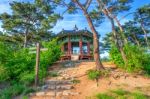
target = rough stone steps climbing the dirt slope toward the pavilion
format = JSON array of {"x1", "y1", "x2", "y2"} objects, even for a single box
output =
[{"x1": 29, "y1": 63, "x2": 80, "y2": 99}]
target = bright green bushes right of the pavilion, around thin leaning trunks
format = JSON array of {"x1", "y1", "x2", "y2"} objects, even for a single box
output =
[{"x1": 110, "y1": 44, "x2": 150, "y2": 74}]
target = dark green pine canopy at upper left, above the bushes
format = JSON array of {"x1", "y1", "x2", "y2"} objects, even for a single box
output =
[{"x1": 0, "y1": 0, "x2": 60, "y2": 44}]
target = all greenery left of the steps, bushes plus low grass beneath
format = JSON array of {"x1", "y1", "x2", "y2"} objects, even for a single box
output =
[{"x1": 0, "y1": 39, "x2": 61, "y2": 99}]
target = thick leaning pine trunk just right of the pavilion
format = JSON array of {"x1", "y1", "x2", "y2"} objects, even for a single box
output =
[{"x1": 74, "y1": 0, "x2": 104, "y2": 70}]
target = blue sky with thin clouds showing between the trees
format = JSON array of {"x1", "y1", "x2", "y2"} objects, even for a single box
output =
[{"x1": 0, "y1": 0, "x2": 150, "y2": 37}]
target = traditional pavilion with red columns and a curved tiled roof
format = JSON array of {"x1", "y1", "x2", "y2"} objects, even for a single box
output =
[{"x1": 57, "y1": 26, "x2": 93, "y2": 61}]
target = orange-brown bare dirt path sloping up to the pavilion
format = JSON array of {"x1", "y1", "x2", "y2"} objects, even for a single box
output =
[{"x1": 30, "y1": 62, "x2": 150, "y2": 99}]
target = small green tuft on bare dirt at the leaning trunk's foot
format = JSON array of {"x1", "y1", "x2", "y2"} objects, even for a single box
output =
[{"x1": 87, "y1": 69, "x2": 101, "y2": 80}]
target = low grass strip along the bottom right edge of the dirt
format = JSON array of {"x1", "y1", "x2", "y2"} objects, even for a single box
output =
[{"x1": 95, "y1": 89, "x2": 150, "y2": 99}]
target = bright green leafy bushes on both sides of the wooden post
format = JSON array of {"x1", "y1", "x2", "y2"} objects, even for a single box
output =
[{"x1": 0, "y1": 40, "x2": 61, "y2": 85}]
